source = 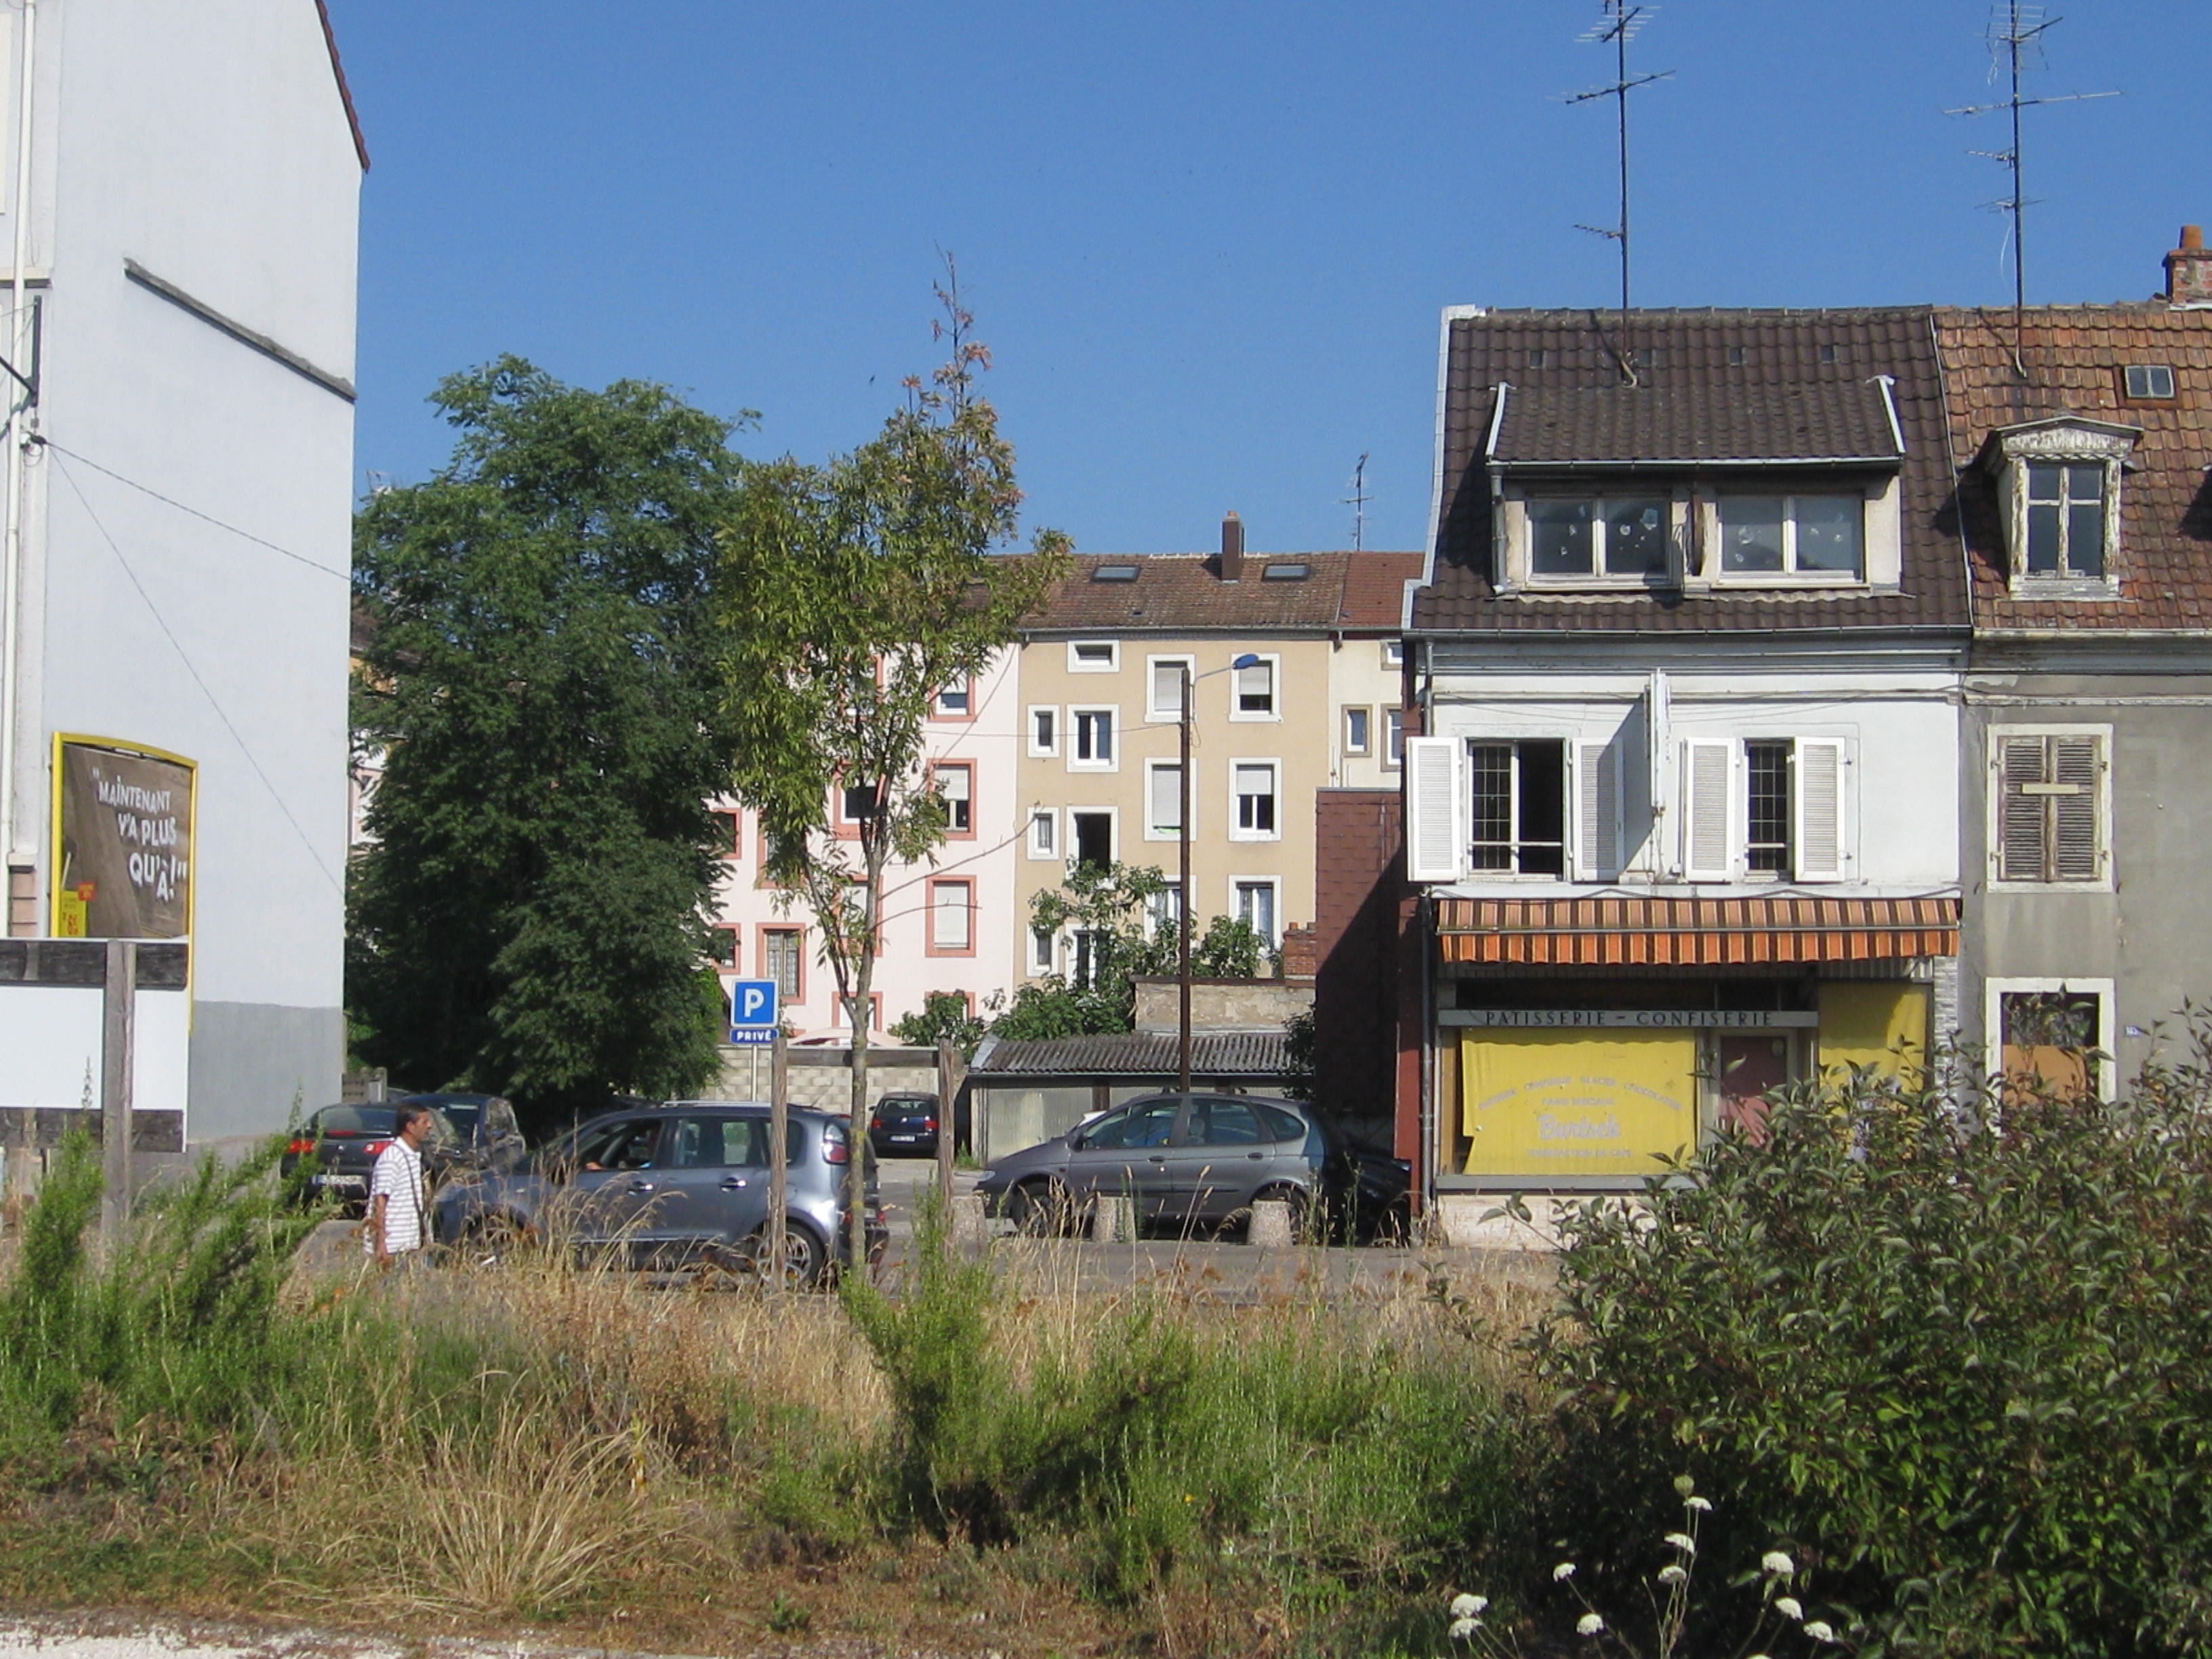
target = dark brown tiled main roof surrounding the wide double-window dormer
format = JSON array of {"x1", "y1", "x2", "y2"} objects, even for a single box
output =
[{"x1": 1414, "y1": 308, "x2": 1967, "y2": 633}]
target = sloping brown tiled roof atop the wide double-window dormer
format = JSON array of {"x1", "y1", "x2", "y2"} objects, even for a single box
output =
[{"x1": 1491, "y1": 380, "x2": 1898, "y2": 467}]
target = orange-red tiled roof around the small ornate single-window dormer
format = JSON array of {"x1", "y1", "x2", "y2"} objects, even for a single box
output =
[{"x1": 1936, "y1": 301, "x2": 2212, "y2": 630}]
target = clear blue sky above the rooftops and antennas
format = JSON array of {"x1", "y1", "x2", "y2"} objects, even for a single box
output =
[{"x1": 329, "y1": 0, "x2": 2212, "y2": 553}]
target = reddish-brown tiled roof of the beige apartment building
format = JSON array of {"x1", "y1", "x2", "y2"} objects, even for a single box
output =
[{"x1": 1022, "y1": 553, "x2": 1420, "y2": 633}]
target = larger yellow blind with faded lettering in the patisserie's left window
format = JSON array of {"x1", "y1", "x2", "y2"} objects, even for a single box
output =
[{"x1": 1460, "y1": 1029, "x2": 1696, "y2": 1181}]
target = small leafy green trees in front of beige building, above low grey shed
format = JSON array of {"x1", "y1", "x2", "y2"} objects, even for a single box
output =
[{"x1": 991, "y1": 863, "x2": 1274, "y2": 1040}]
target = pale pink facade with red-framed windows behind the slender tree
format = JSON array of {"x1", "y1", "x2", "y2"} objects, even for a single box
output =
[{"x1": 714, "y1": 651, "x2": 1022, "y2": 1042}]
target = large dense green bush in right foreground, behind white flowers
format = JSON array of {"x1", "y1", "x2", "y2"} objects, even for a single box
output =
[{"x1": 1537, "y1": 1066, "x2": 2212, "y2": 1654}]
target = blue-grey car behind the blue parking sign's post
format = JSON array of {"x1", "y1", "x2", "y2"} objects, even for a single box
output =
[{"x1": 431, "y1": 1099, "x2": 889, "y2": 1283}]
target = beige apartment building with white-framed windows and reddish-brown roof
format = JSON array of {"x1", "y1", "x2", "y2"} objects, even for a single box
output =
[{"x1": 1015, "y1": 513, "x2": 1420, "y2": 978}]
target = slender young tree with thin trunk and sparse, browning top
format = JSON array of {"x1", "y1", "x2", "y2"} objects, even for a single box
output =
[{"x1": 721, "y1": 261, "x2": 1066, "y2": 1261}]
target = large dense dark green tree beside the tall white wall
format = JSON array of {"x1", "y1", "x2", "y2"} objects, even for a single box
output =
[{"x1": 347, "y1": 356, "x2": 741, "y2": 1122}]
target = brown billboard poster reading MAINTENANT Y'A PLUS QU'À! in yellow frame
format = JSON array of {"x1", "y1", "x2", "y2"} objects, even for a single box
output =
[{"x1": 49, "y1": 737, "x2": 194, "y2": 938}]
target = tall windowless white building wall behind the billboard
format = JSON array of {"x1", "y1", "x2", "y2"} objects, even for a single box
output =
[{"x1": 0, "y1": 0, "x2": 361, "y2": 1139}]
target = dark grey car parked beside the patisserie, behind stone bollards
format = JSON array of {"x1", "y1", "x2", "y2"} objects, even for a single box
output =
[{"x1": 978, "y1": 1092, "x2": 1343, "y2": 1232}]
